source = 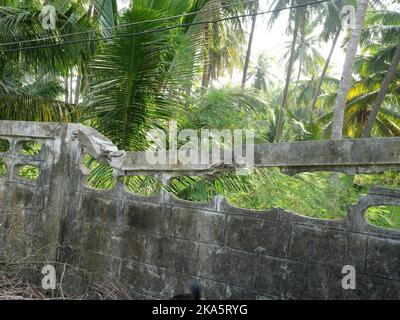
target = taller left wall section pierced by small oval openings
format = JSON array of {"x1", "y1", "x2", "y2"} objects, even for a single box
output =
[{"x1": 0, "y1": 122, "x2": 69, "y2": 264}]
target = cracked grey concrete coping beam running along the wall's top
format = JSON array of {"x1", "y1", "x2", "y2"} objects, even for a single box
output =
[{"x1": 0, "y1": 121, "x2": 400, "y2": 180}]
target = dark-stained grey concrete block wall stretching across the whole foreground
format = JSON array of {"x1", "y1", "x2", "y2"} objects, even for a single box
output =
[{"x1": 0, "y1": 121, "x2": 400, "y2": 299}]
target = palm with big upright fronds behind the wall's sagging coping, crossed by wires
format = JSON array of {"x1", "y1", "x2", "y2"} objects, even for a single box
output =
[{"x1": 85, "y1": 0, "x2": 255, "y2": 149}]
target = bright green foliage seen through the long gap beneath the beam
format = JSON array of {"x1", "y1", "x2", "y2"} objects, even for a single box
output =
[{"x1": 171, "y1": 169, "x2": 356, "y2": 219}]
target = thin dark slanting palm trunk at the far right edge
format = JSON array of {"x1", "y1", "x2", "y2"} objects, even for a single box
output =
[{"x1": 362, "y1": 44, "x2": 400, "y2": 138}]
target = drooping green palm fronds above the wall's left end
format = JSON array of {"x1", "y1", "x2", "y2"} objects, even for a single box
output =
[{"x1": 0, "y1": 1, "x2": 96, "y2": 121}]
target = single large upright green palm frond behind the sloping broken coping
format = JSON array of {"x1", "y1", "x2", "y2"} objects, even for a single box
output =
[{"x1": 85, "y1": 6, "x2": 189, "y2": 150}]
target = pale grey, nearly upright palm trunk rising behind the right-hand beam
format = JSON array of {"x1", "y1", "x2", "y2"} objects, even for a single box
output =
[{"x1": 332, "y1": 0, "x2": 368, "y2": 140}]
